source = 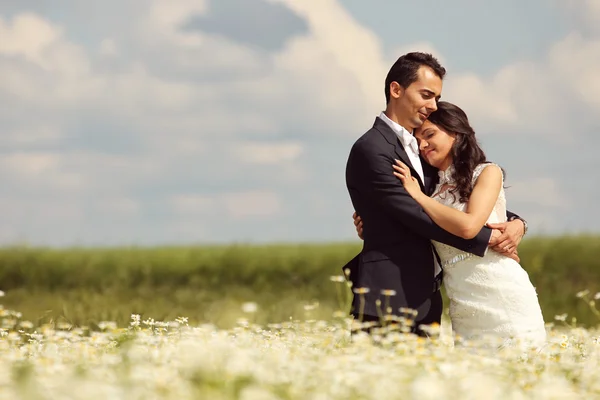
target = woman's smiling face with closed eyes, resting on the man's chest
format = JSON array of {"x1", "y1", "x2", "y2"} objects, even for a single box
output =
[{"x1": 415, "y1": 121, "x2": 455, "y2": 170}]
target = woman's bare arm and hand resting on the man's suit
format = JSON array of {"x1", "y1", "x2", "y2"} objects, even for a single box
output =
[{"x1": 395, "y1": 161, "x2": 502, "y2": 239}]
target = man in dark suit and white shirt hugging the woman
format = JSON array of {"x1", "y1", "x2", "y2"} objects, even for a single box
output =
[{"x1": 343, "y1": 52, "x2": 526, "y2": 336}]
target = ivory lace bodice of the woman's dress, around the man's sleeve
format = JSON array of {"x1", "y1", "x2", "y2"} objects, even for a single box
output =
[{"x1": 432, "y1": 163, "x2": 506, "y2": 268}]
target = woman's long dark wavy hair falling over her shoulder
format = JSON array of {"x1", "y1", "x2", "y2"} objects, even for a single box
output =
[{"x1": 428, "y1": 101, "x2": 504, "y2": 203}]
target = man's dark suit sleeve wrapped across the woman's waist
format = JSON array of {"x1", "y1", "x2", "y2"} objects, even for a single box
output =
[{"x1": 353, "y1": 146, "x2": 492, "y2": 257}]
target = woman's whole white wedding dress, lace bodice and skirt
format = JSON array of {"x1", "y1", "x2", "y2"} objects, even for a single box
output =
[{"x1": 432, "y1": 163, "x2": 546, "y2": 347}]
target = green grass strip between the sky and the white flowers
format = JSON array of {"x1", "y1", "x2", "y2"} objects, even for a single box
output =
[{"x1": 0, "y1": 236, "x2": 600, "y2": 327}]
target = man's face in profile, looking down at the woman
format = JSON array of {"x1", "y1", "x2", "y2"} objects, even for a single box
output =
[{"x1": 391, "y1": 66, "x2": 442, "y2": 130}]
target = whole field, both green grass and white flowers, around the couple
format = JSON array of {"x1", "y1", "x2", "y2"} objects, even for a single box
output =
[{"x1": 0, "y1": 237, "x2": 600, "y2": 400}]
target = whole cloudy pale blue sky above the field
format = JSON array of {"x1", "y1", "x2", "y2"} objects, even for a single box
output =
[{"x1": 0, "y1": 0, "x2": 600, "y2": 246}]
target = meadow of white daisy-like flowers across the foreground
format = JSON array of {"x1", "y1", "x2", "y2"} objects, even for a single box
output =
[{"x1": 0, "y1": 292, "x2": 600, "y2": 400}]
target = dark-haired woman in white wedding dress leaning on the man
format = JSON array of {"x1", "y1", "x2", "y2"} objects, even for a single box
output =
[{"x1": 394, "y1": 101, "x2": 546, "y2": 346}]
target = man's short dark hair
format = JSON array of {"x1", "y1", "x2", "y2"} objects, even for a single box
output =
[{"x1": 385, "y1": 52, "x2": 446, "y2": 104}]
